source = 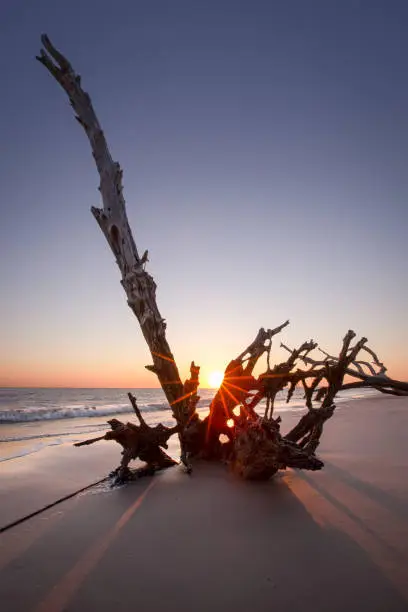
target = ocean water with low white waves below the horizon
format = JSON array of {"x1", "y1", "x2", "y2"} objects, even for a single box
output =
[{"x1": 0, "y1": 388, "x2": 378, "y2": 462}]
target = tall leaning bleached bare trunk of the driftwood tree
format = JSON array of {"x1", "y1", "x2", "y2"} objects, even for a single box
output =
[{"x1": 37, "y1": 35, "x2": 189, "y2": 425}]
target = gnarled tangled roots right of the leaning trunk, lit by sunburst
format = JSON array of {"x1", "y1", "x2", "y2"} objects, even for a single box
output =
[{"x1": 201, "y1": 327, "x2": 404, "y2": 480}]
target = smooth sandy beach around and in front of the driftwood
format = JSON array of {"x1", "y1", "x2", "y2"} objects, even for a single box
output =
[{"x1": 0, "y1": 397, "x2": 408, "y2": 612}]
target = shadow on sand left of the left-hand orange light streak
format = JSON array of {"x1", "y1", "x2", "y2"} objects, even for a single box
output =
[{"x1": 0, "y1": 478, "x2": 155, "y2": 612}]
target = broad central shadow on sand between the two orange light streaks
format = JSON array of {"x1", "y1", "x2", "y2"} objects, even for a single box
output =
[{"x1": 59, "y1": 467, "x2": 407, "y2": 612}]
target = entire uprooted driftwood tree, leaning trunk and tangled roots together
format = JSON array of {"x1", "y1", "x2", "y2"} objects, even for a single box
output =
[{"x1": 37, "y1": 35, "x2": 408, "y2": 480}]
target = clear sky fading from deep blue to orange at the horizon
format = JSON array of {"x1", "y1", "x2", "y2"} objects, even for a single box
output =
[{"x1": 0, "y1": 0, "x2": 408, "y2": 388}]
